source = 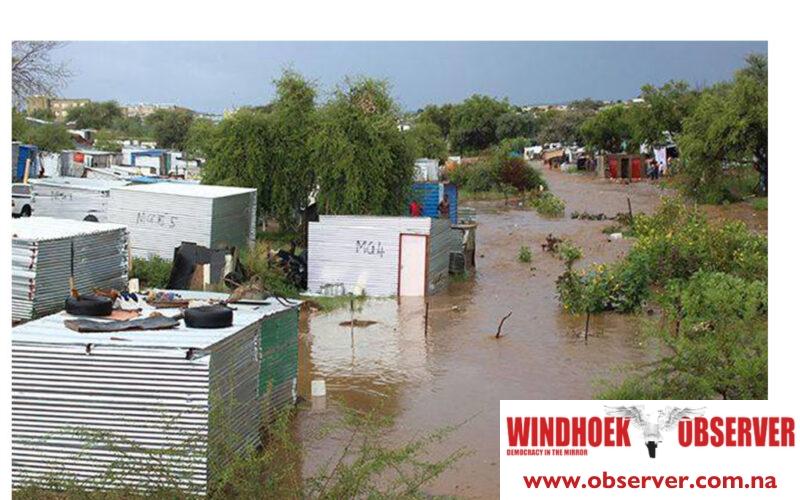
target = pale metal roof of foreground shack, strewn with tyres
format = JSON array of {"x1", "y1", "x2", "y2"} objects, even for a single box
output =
[{"x1": 11, "y1": 290, "x2": 300, "y2": 350}]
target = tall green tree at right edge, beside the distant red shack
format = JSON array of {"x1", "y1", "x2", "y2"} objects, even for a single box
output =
[{"x1": 678, "y1": 55, "x2": 768, "y2": 202}]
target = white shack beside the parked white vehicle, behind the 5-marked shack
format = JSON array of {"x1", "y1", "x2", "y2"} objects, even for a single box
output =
[{"x1": 29, "y1": 177, "x2": 128, "y2": 222}]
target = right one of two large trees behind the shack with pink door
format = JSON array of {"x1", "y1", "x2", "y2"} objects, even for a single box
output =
[{"x1": 314, "y1": 78, "x2": 414, "y2": 215}]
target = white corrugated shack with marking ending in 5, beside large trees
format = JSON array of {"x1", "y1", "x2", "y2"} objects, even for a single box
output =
[{"x1": 109, "y1": 182, "x2": 257, "y2": 260}]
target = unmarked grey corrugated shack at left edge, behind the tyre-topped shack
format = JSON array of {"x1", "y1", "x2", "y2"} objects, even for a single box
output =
[{"x1": 11, "y1": 217, "x2": 128, "y2": 321}]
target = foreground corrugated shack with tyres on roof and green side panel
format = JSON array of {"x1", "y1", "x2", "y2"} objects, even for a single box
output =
[{"x1": 11, "y1": 291, "x2": 299, "y2": 495}]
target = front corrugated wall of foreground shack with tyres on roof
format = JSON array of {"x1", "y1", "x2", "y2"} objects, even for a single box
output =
[{"x1": 11, "y1": 342, "x2": 209, "y2": 494}]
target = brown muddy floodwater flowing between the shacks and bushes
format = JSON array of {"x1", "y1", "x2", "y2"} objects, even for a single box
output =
[{"x1": 290, "y1": 166, "x2": 766, "y2": 498}]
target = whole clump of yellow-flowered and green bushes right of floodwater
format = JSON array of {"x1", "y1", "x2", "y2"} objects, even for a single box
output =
[{"x1": 557, "y1": 200, "x2": 767, "y2": 399}]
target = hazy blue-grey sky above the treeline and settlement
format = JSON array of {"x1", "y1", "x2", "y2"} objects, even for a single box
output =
[{"x1": 54, "y1": 42, "x2": 767, "y2": 113}]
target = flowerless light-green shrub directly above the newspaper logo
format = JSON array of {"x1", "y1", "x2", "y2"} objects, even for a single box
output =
[{"x1": 601, "y1": 271, "x2": 767, "y2": 399}]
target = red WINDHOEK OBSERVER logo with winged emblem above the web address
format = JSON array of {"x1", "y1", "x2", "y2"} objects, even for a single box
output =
[{"x1": 506, "y1": 406, "x2": 795, "y2": 458}]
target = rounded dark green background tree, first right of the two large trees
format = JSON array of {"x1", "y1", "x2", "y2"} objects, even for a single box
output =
[{"x1": 450, "y1": 94, "x2": 511, "y2": 153}]
